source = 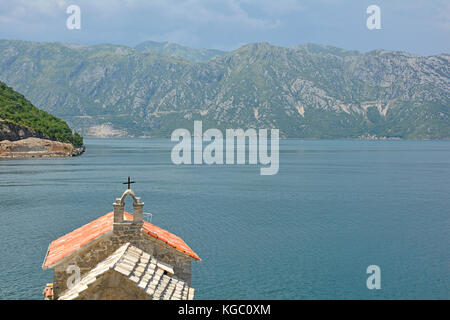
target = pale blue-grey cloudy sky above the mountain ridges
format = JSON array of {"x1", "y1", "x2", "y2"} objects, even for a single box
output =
[{"x1": 0, "y1": 0, "x2": 450, "y2": 55}]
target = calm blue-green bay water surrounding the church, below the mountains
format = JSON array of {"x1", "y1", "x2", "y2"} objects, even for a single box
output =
[{"x1": 0, "y1": 139, "x2": 450, "y2": 299}]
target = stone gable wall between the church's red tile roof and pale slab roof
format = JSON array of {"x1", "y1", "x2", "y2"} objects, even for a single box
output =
[{"x1": 53, "y1": 222, "x2": 192, "y2": 299}]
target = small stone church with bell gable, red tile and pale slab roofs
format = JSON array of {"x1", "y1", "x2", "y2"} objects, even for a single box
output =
[{"x1": 42, "y1": 185, "x2": 200, "y2": 300}]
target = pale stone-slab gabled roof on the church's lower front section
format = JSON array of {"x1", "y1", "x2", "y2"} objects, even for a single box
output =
[{"x1": 59, "y1": 243, "x2": 194, "y2": 300}]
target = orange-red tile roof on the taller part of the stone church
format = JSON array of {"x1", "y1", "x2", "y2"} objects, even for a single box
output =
[{"x1": 43, "y1": 212, "x2": 200, "y2": 269}]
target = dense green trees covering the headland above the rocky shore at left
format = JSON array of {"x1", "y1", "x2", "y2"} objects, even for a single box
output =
[{"x1": 0, "y1": 82, "x2": 83, "y2": 147}]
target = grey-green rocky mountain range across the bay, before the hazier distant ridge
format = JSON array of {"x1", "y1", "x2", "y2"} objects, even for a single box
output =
[{"x1": 0, "y1": 40, "x2": 450, "y2": 139}]
